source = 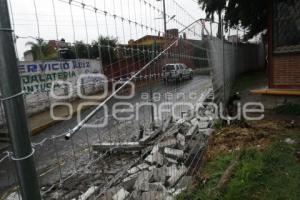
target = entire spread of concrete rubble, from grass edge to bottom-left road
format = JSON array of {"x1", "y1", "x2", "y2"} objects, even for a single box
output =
[{"x1": 41, "y1": 89, "x2": 214, "y2": 200}]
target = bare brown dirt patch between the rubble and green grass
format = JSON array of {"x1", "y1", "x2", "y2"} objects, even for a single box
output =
[{"x1": 206, "y1": 119, "x2": 300, "y2": 160}]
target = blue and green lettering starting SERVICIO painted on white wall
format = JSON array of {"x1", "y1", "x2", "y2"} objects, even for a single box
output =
[{"x1": 18, "y1": 59, "x2": 103, "y2": 93}]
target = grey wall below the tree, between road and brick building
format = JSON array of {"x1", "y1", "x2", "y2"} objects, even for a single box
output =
[{"x1": 208, "y1": 38, "x2": 265, "y2": 102}]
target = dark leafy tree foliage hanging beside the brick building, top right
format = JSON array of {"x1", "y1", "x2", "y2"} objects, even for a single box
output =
[{"x1": 199, "y1": 0, "x2": 268, "y2": 39}]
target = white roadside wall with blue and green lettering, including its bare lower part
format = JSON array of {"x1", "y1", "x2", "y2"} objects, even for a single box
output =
[{"x1": 0, "y1": 59, "x2": 103, "y2": 126}]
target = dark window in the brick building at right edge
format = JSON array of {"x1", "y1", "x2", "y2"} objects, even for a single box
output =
[{"x1": 273, "y1": 0, "x2": 300, "y2": 53}]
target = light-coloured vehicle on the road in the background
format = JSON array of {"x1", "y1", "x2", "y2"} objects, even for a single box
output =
[{"x1": 162, "y1": 63, "x2": 193, "y2": 83}]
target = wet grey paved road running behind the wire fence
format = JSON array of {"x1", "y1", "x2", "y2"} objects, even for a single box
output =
[{"x1": 0, "y1": 76, "x2": 211, "y2": 194}]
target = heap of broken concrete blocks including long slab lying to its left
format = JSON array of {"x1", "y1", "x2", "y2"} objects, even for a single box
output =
[{"x1": 78, "y1": 90, "x2": 213, "y2": 200}]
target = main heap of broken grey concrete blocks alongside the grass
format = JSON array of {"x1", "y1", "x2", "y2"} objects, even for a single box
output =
[{"x1": 101, "y1": 115, "x2": 212, "y2": 200}]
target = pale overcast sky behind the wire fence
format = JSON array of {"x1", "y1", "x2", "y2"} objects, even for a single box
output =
[{"x1": 9, "y1": 0, "x2": 211, "y2": 58}]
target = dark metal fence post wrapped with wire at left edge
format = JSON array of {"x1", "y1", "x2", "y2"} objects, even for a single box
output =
[{"x1": 0, "y1": 0, "x2": 41, "y2": 200}]
